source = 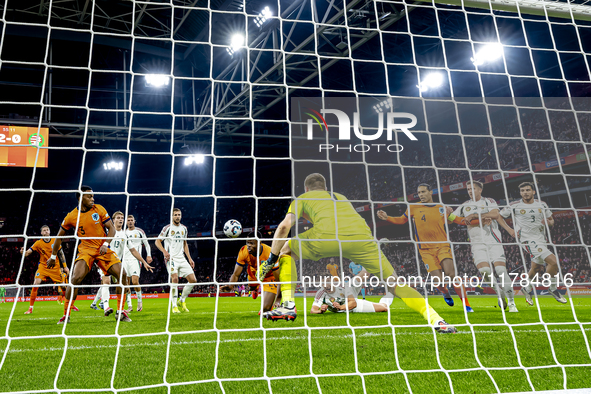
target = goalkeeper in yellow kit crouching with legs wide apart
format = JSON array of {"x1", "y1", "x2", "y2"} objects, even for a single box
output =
[{"x1": 257, "y1": 174, "x2": 457, "y2": 333}]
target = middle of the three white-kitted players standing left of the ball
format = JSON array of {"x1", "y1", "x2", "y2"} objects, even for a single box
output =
[{"x1": 121, "y1": 215, "x2": 153, "y2": 312}]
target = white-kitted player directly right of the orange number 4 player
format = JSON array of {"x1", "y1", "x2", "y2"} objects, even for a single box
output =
[{"x1": 454, "y1": 181, "x2": 518, "y2": 312}]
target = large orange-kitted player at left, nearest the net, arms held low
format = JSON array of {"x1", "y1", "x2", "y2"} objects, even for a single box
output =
[{"x1": 47, "y1": 186, "x2": 131, "y2": 324}]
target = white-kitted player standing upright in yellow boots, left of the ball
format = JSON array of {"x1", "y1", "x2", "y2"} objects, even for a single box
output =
[{"x1": 156, "y1": 208, "x2": 197, "y2": 313}]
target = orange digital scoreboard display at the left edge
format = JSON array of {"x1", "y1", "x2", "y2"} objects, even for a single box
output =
[{"x1": 0, "y1": 125, "x2": 49, "y2": 168}]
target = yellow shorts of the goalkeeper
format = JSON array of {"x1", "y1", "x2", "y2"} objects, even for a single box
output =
[{"x1": 289, "y1": 228, "x2": 395, "y2": 280}]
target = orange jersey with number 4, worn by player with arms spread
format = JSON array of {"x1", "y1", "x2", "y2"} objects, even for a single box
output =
[{"x1": 404, "y1": 204, "x2": 449, "y2": 249}]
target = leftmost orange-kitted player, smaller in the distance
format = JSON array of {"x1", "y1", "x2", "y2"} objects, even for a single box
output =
[{"x1": 21, "y1": 226, "x2": 71, "y2": 315}]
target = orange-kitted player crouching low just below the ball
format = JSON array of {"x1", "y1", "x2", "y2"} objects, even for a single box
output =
[{"x1": 220, "y1": 231, "x2": 279, "y2": 312}]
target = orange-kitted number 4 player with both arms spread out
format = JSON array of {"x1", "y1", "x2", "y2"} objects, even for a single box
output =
[{"x1": 377, "y1": 183, "x2": 490, "y2": 312}]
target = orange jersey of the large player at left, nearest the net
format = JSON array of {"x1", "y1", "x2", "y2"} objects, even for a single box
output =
[{"x1": 62, "y1": 204, "x2": 111, "y2": 249}]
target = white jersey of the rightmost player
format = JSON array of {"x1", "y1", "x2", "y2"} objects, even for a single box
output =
[{"x1": 501, "y1": 200, "x2": 552, "y2": 243}]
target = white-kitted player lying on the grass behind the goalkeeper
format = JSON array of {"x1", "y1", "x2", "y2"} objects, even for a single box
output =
[{"x1": 310, "y1": 270, "x2": 392, "y2": 314}]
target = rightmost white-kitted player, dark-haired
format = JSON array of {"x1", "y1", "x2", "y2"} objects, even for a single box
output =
[{"x1": 499, "y1": 182, "x2": 567, "y2": 305}]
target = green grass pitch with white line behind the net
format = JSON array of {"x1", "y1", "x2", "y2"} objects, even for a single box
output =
[{"x1": 0, "y1": 296, "x2": 591, "y2": 394}]
